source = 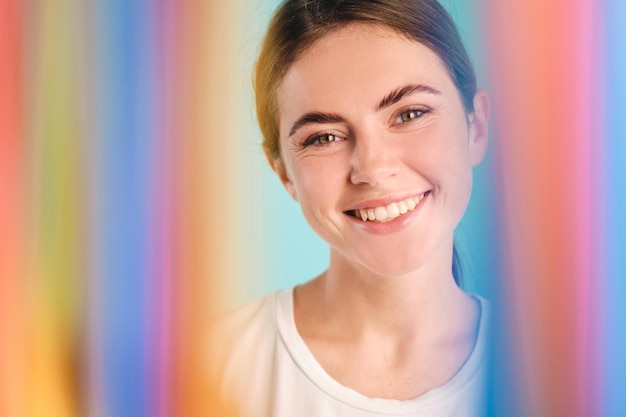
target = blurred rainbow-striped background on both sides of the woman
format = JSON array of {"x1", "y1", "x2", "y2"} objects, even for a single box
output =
[{"x1": 0, "y1": 0, "x2": 626, "y2": 417}]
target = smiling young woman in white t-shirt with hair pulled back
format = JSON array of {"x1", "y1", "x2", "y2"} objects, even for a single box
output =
[{"x1": 211, "y1": 0, "x2": 488, "y2": 417}]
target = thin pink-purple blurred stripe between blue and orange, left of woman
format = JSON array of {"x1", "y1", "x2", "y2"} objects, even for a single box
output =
[{"x1": 147, "y1": 0, "x2": 176, "y2": 417}]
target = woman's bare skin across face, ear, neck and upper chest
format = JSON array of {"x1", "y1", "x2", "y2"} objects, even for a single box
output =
[{"x1": 274, "y1": 25, "x2": 488, "y2": 400}]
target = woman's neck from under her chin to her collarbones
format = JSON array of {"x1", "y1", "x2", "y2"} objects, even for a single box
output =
[{"x1": 296, "y1": 239, "x2": 476, "y2": 340}]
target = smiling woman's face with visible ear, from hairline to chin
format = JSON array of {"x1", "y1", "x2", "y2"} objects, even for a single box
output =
[{"x1": 275, "y1": 25, "x2": 487, "y2": 275}]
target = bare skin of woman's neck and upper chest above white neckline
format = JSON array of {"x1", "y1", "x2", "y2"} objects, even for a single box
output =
[{"x1": 294, "y1": 244, "x2": 480, "y2": 400}]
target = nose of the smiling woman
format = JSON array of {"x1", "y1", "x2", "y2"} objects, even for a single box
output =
[{"x1": 350, "y1": 134, "x2": 399, "y2": 186}]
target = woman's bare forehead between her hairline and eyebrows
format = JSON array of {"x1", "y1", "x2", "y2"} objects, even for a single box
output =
[{"x1": 277, "y1": 24, "x2": 458, "y2": 131}]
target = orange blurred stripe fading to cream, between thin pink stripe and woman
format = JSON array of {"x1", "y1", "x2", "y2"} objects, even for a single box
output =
[{"x1": 171, "y1": 2, "x2": 242, "y2": 416}]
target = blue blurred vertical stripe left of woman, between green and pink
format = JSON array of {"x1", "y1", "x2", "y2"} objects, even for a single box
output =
[{"x1": 93, "y1": 0, "x2": 152, "y2": 417}]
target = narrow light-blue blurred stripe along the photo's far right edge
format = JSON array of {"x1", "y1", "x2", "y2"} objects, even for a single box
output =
[{"x1": 601, "y1": 0, "x2": 626, "y2": 417}]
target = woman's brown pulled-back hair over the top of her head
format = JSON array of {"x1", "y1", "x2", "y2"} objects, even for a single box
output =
[{"x1": 254, "y1": 0, "x2": 476, "y2": 160}]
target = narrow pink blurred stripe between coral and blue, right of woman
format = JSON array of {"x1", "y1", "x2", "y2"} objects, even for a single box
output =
[{"x1": 569, "y1": 0, "x2": 602, "y2": 415}]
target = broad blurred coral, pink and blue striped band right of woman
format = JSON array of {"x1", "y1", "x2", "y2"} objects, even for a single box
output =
[{"x1": 485, "y1": 1, "x2": 626, "y2": 416}]
